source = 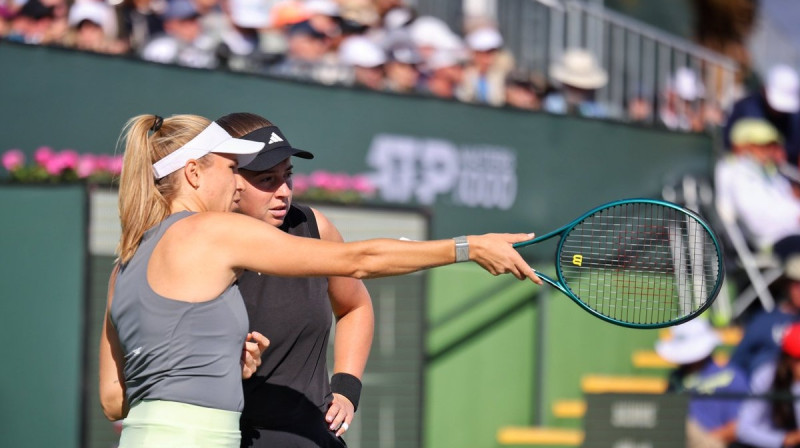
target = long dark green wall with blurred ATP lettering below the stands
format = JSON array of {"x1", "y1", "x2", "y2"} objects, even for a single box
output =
[{"x1": 0, "y1": 44, "x2": 711, "y2": 242}]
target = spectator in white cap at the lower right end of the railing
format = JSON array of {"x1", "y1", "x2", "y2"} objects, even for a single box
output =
[{"x1": 658, "y1": 67, "x2": 705, "y2": 132}]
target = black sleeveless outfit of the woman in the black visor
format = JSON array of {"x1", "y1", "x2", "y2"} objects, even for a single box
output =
[{"x1": 239, "y1": 204, "x2": 340, "y2": 446}]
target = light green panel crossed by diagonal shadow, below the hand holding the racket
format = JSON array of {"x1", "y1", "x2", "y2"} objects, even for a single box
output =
[{"x1": 424, "y1": 264, "x2": 540, "y2": 448}]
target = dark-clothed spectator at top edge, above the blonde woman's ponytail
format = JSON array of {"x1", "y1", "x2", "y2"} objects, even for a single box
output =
[{"x1": 119, "y1": 0, "x2": 167, "y2": 52}]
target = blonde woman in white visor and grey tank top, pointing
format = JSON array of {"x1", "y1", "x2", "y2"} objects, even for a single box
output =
[{"x1": 100, "y1": 115, "x2": 541, "y2": 448}]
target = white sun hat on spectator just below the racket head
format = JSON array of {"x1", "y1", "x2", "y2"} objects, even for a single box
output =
[{"x1": 656, "y1": 318, "x2": 721, "y2": 364}]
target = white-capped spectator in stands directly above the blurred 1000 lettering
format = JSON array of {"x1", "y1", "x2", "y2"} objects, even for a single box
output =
[{"x1": 461, "y1": 27, "x2": 511, "y2": 106}]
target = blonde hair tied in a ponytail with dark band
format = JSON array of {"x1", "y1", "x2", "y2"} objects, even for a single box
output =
[{"x1": 117, "y1": 115, "x2": 210, "y2": 264}]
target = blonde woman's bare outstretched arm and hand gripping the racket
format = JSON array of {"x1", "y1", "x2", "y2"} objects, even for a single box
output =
[{"x1": 208, "y1": 213, "x2": 541, "y2": 284}]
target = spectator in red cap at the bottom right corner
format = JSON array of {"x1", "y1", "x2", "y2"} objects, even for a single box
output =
[{"x1": 737, "y1": 318, "x2": 800, "y2": 448}]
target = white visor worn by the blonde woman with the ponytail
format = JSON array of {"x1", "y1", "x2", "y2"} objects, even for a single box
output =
[{"x1": 153, "y1": 121, "x2": 264, "y2": 179}]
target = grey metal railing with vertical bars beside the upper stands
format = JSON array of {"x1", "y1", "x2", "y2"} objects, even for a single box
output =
[{"x1": 497, "y1": 0, "x2": 737, "y2": 119}]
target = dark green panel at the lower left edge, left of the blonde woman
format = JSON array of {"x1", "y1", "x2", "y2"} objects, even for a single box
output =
[{"x1": 0, "y1": 185, "x2": 87, "y2": 448}]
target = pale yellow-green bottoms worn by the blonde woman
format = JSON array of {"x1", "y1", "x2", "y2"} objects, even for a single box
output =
[{"x1": 119, "y1": 400, "x2": 241, "y2": 448}]
